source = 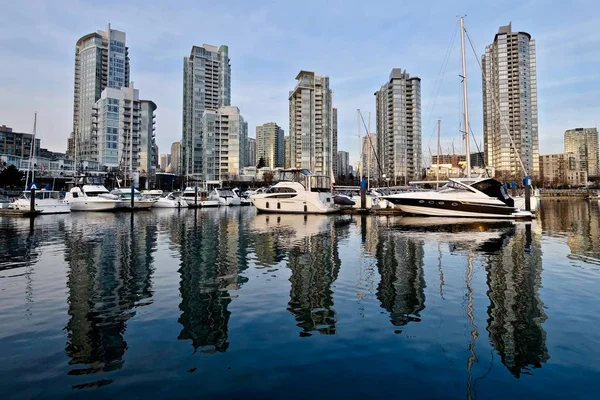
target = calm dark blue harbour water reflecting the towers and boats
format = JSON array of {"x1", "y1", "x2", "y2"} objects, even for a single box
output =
[{"x1": 0, "y1": 201, "x2": 600, "y2": 399}]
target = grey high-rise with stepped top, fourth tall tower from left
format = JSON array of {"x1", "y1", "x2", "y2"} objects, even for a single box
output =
[{"x1": 375, "y1": 68, "x2": 422, "y2": 185}]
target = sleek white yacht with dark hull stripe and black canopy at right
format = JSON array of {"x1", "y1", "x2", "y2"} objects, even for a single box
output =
[{"x1": 384, "y1": 178, "x2": 532, "y2": 219}]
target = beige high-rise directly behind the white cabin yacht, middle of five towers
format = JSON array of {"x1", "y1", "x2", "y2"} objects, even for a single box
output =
[{"x1": 289, "y1": 71, "x2": 334, "y2": 176}]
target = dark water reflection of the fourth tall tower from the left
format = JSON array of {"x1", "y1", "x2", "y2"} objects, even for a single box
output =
[{"x1": 376, "y1": 225, "x2": 425, "y2": 326}]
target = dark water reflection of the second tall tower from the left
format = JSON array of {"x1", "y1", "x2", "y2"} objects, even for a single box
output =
[{"x1": 178, "y1": 208, "x2": 248, "y2": 353}]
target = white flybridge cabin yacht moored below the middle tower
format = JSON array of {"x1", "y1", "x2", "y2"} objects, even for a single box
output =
[{"x1": 250, "y1": 169, "x2": 339, "y2": 214}]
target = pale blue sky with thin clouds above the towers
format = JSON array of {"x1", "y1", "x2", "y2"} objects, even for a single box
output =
[{"x1": 0, "y1": 0, "x2": 600, "y2": 166}]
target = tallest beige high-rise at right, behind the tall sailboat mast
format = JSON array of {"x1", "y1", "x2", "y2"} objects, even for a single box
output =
[{"x1": 481, "y1": 24, "x2": 540, "y2": 177}]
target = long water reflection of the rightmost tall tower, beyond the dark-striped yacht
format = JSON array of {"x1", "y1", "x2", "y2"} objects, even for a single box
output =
[{"x1": 486, "y1": 224, "x2": 550, "y2": 377}]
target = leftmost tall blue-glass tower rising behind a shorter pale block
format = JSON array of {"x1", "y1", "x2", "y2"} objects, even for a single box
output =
[{"x1": 67, "y1": 24, "x2": 129, "y2": 161}]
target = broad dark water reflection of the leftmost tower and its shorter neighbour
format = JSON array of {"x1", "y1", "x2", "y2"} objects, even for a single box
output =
[{"x1": 65, "y1": 213, "x2": 157, "y2": 388}]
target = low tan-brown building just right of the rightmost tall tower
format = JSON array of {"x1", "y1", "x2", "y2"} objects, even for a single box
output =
[{"x1": 539, "y1": 153, "x2": 588, "y2": 187}]
